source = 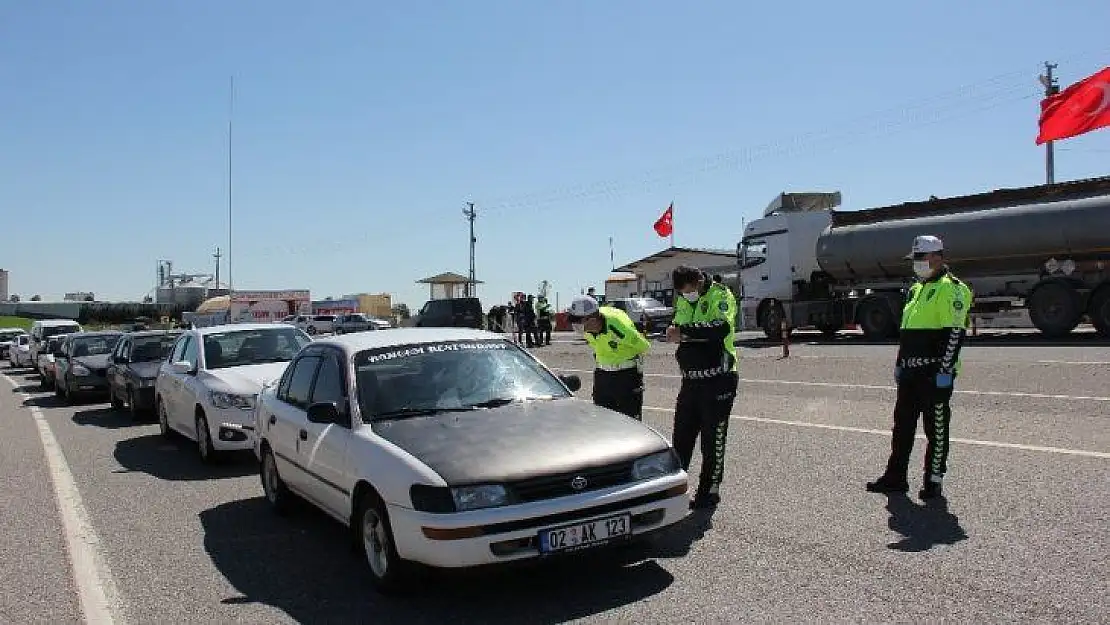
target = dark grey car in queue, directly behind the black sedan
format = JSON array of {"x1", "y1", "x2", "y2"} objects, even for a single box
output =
[{"x1": 54, "y1": 330, "x2": 123, "y2": 402}]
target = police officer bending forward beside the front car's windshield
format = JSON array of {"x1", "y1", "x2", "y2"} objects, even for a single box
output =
[{"x1": 567, "y1": 295, "x2": 652, "y2": 421}]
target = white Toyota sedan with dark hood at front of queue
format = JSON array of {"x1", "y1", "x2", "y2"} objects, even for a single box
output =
[{"x1": 255, "y1": 329, "x2": 689, "y2": 592}]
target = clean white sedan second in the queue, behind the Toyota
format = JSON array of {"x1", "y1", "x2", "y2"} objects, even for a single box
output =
[{"x1": 154, "y1": 323, "x2": 312, "y2": 462}]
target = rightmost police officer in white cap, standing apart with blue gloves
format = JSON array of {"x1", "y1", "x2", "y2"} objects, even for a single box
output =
[{"x1": 867, "y1": 235, "x2": 972, "y2": 498}]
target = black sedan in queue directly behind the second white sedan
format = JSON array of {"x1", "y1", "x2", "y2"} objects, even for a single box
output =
[{"x1": 108, "y1": 330, "x2": 182, "y2": 419}]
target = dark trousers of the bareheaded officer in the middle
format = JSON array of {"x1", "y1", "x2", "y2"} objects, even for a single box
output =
[{"x1": 672, "y1": 373, "x2": 739, "y2": 496}]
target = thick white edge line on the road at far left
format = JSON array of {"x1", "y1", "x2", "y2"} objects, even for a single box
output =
[{"x1": 0, "y1": 374, "x2": 123, "y2": 625}]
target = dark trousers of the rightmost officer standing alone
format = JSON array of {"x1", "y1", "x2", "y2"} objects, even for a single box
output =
[{"x1": 886, "y1": 371, "x2": 955, "y2": 482}]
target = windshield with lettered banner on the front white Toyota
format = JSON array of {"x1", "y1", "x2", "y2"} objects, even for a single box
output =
[{"x1": 354, "y1": 339, "x2": 571, "y2": 419}]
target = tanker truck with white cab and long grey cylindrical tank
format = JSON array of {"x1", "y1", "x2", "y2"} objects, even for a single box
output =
[{"x1": 737, "y1": 177, "x2": 1110, "y2": 339}]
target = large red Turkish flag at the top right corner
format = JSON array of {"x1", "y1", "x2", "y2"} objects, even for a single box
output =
[{"x1": 1037, "y1": 68, "x2": 1110, "y2": 145}]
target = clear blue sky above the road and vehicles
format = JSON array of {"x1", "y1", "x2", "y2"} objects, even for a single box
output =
[{"x1": 0, "y1": 0, "x2": 1110, "y2": 308}]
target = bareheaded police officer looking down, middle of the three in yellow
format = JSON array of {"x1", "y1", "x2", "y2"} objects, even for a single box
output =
[{"x1": 667, "y1": 266, "x2": 739, "y2": 508}]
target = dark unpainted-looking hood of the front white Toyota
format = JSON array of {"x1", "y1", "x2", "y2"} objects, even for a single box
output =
[{"x1": 372, "y1": 399, "x2": 669, "y2": 486}]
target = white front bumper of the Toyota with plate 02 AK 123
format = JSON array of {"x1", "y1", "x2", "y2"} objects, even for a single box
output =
[{"x1": 389, "y1": 472, "x2": 689, "y2": 568}]
